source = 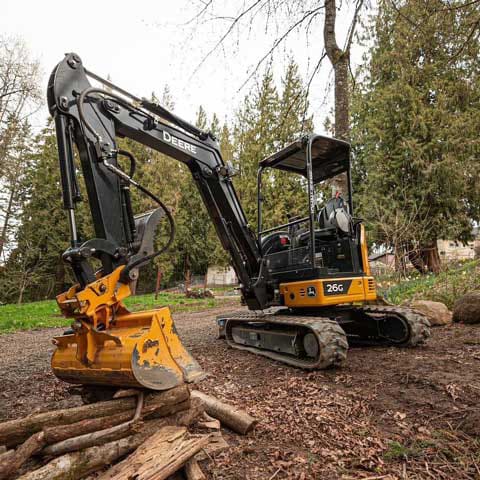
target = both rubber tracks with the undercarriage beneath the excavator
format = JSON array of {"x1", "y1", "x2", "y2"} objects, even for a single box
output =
[{"x1": 217, "y1": 305, "x2": 430, "y2": 370}]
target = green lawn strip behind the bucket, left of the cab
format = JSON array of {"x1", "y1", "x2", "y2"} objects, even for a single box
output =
[{"x1": 0, "y1": 293, "x2": 236, "y2": 334}]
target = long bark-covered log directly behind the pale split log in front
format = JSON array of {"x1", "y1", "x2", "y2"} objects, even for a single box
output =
[{"x1": 18, "y1": 400, "x2": 204, "y2": 480}]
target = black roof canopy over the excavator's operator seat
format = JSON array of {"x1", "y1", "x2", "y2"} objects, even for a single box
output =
[{"x1": 260, "y1": 134, "x2": 350, "y2": 183}]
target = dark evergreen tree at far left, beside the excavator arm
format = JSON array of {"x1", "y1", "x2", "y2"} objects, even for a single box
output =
[{"x1": 0, "y1": 127, "x2": 91, "y2": 303}]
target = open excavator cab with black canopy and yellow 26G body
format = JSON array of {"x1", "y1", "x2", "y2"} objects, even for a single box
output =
[{"x1": 257, "y1": 135, "x2": 376, "y2": 308}]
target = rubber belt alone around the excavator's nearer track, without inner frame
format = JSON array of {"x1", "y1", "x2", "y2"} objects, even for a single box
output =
[{"x1": 219, "y1": 311, "x2": 348, "y2": 370}]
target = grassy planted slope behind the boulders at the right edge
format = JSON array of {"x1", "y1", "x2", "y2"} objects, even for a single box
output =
[{"x1": 378, "y1": 260, "x2": 480, "y2": 309}]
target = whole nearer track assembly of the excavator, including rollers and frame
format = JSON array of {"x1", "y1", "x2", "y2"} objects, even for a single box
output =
[{"x1": 217, "y1": 311, "x2": 348, "y2": 370}]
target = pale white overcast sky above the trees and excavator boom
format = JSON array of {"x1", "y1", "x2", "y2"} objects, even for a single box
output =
[{"x1": 0, "y1": 0, "x2": 368, "y2": 133}]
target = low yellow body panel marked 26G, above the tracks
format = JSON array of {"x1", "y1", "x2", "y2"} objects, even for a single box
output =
[{"x1": 280, "y1": 276, "x2": 377, "y2": 308}]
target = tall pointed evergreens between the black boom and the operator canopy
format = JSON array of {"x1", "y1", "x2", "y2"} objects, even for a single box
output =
[{"x1": 234, "y1": 61, "x2": 313, "y2": 228}]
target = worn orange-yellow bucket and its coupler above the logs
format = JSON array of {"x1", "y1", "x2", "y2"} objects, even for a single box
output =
[{"x1": 52, "y1": 267, "x2": 203, "y2": 390}]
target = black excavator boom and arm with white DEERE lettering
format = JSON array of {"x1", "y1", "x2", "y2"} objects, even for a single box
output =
[{"x1": 48, "y1": 53, "x2": 269, "y2": 310}]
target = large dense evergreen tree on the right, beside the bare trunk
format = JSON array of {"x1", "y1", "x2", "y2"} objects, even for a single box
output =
[{"x1": 352, "y1": 0, "x2": 480, "y2": 258}]
